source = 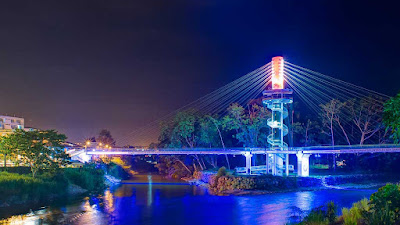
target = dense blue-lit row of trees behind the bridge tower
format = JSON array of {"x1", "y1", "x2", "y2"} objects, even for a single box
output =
[{"x1": 153, "y1": 94, "x2": 400, "y2": 174}]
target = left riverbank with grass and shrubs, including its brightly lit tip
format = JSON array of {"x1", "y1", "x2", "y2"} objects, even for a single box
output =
[{"x1": 0, "y1": 164, "x2": 125, "y2": 216}]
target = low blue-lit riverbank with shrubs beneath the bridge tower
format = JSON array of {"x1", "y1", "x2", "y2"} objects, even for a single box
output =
[{"x1": 190, "y1": 169, "x2": 400, "y2": 195}]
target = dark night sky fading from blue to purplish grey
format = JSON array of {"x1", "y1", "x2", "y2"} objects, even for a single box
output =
[{"x1": 0, "y1": 0, "x2": 400, "y2": 145}]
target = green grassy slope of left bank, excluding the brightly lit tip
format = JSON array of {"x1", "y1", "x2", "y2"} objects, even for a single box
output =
[{"x1": 0, "y1": 165, "x2": 105, "y2": 207}]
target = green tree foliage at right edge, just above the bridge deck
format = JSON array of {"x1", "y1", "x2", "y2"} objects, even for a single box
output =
[{"x1": 383, "y1": 93, "x2": 400, "y2": 143}]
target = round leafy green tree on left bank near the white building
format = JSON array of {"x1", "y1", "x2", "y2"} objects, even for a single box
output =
[{"x1": 10, "y1": 130, "x2": 68, "y2": 177}]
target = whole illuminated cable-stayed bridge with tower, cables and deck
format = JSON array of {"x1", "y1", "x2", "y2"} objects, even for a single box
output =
[{"x1": 67, "y1": 57, "x2": 400, "y2": 176}]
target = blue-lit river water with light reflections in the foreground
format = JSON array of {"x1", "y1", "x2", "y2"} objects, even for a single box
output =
[{"x1": 0, "y1": 175, "x2": 376, "y2": 225}]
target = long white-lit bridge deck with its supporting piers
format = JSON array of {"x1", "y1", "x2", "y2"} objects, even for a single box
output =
[{"x1": 67, "y1": 144, "x2": 400, "y2": 176}]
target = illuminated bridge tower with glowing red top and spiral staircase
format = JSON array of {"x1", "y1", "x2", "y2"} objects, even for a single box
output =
[{"x1": 263, "y1": 56, "x2": 293, "y2": 176}]
